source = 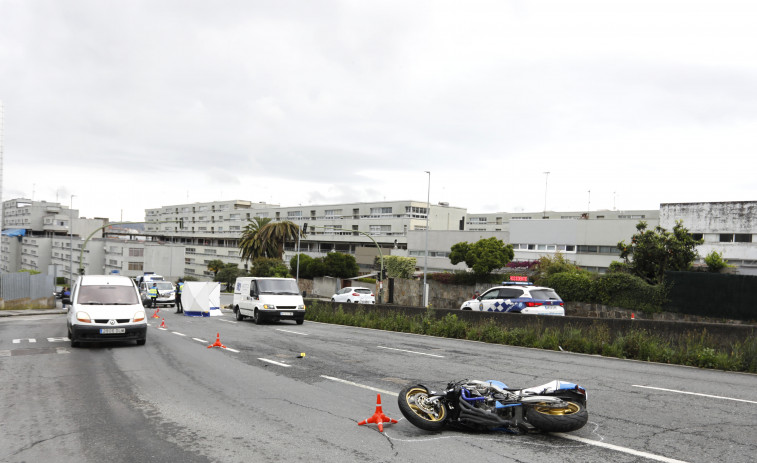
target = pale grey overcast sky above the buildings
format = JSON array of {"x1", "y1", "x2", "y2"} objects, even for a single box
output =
[{"x1": 0, "y1": 0, "x2": 757, "y2": 220}]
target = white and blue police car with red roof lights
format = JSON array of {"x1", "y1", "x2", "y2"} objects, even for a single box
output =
[{"x1": 460, "y1": 285, "x2": 565, "y2": 316}]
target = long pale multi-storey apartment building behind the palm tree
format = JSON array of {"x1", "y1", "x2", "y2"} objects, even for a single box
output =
[{"x1": 145, "y1": 200, "x2": 466, "y2": 277}]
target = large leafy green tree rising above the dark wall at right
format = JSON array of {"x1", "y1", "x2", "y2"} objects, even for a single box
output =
[{"x1": 618, "y1": 220, "x2": 702, "y2": 284}]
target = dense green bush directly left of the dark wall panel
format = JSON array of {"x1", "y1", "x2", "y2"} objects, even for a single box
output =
[{"x1": 586, "y1": 273, "x2": 667, "y2": 312}]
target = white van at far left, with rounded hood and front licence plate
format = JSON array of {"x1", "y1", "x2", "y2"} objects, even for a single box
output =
[{"x1": 65, "y1": 275, "x2": 147, "y2": 347}]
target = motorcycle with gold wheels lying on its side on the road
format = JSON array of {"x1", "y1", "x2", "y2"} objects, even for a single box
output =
[{"x1": 398, "y1": 379, "x2": 589, "y2": 433}]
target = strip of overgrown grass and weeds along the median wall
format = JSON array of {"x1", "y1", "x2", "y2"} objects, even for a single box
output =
[{"x1": 306, "y1": 302, "x2": 757, "y2": 373}]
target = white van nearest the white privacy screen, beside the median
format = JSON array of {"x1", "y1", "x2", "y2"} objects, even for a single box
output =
[{"x1": 232, "y1": 277, "x2": 305, "y2": 325}]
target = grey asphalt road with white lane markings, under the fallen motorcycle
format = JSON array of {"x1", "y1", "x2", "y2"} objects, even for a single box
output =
[{"x1": 0, "y1": 309, "x2": 757, "y2": 463}]
